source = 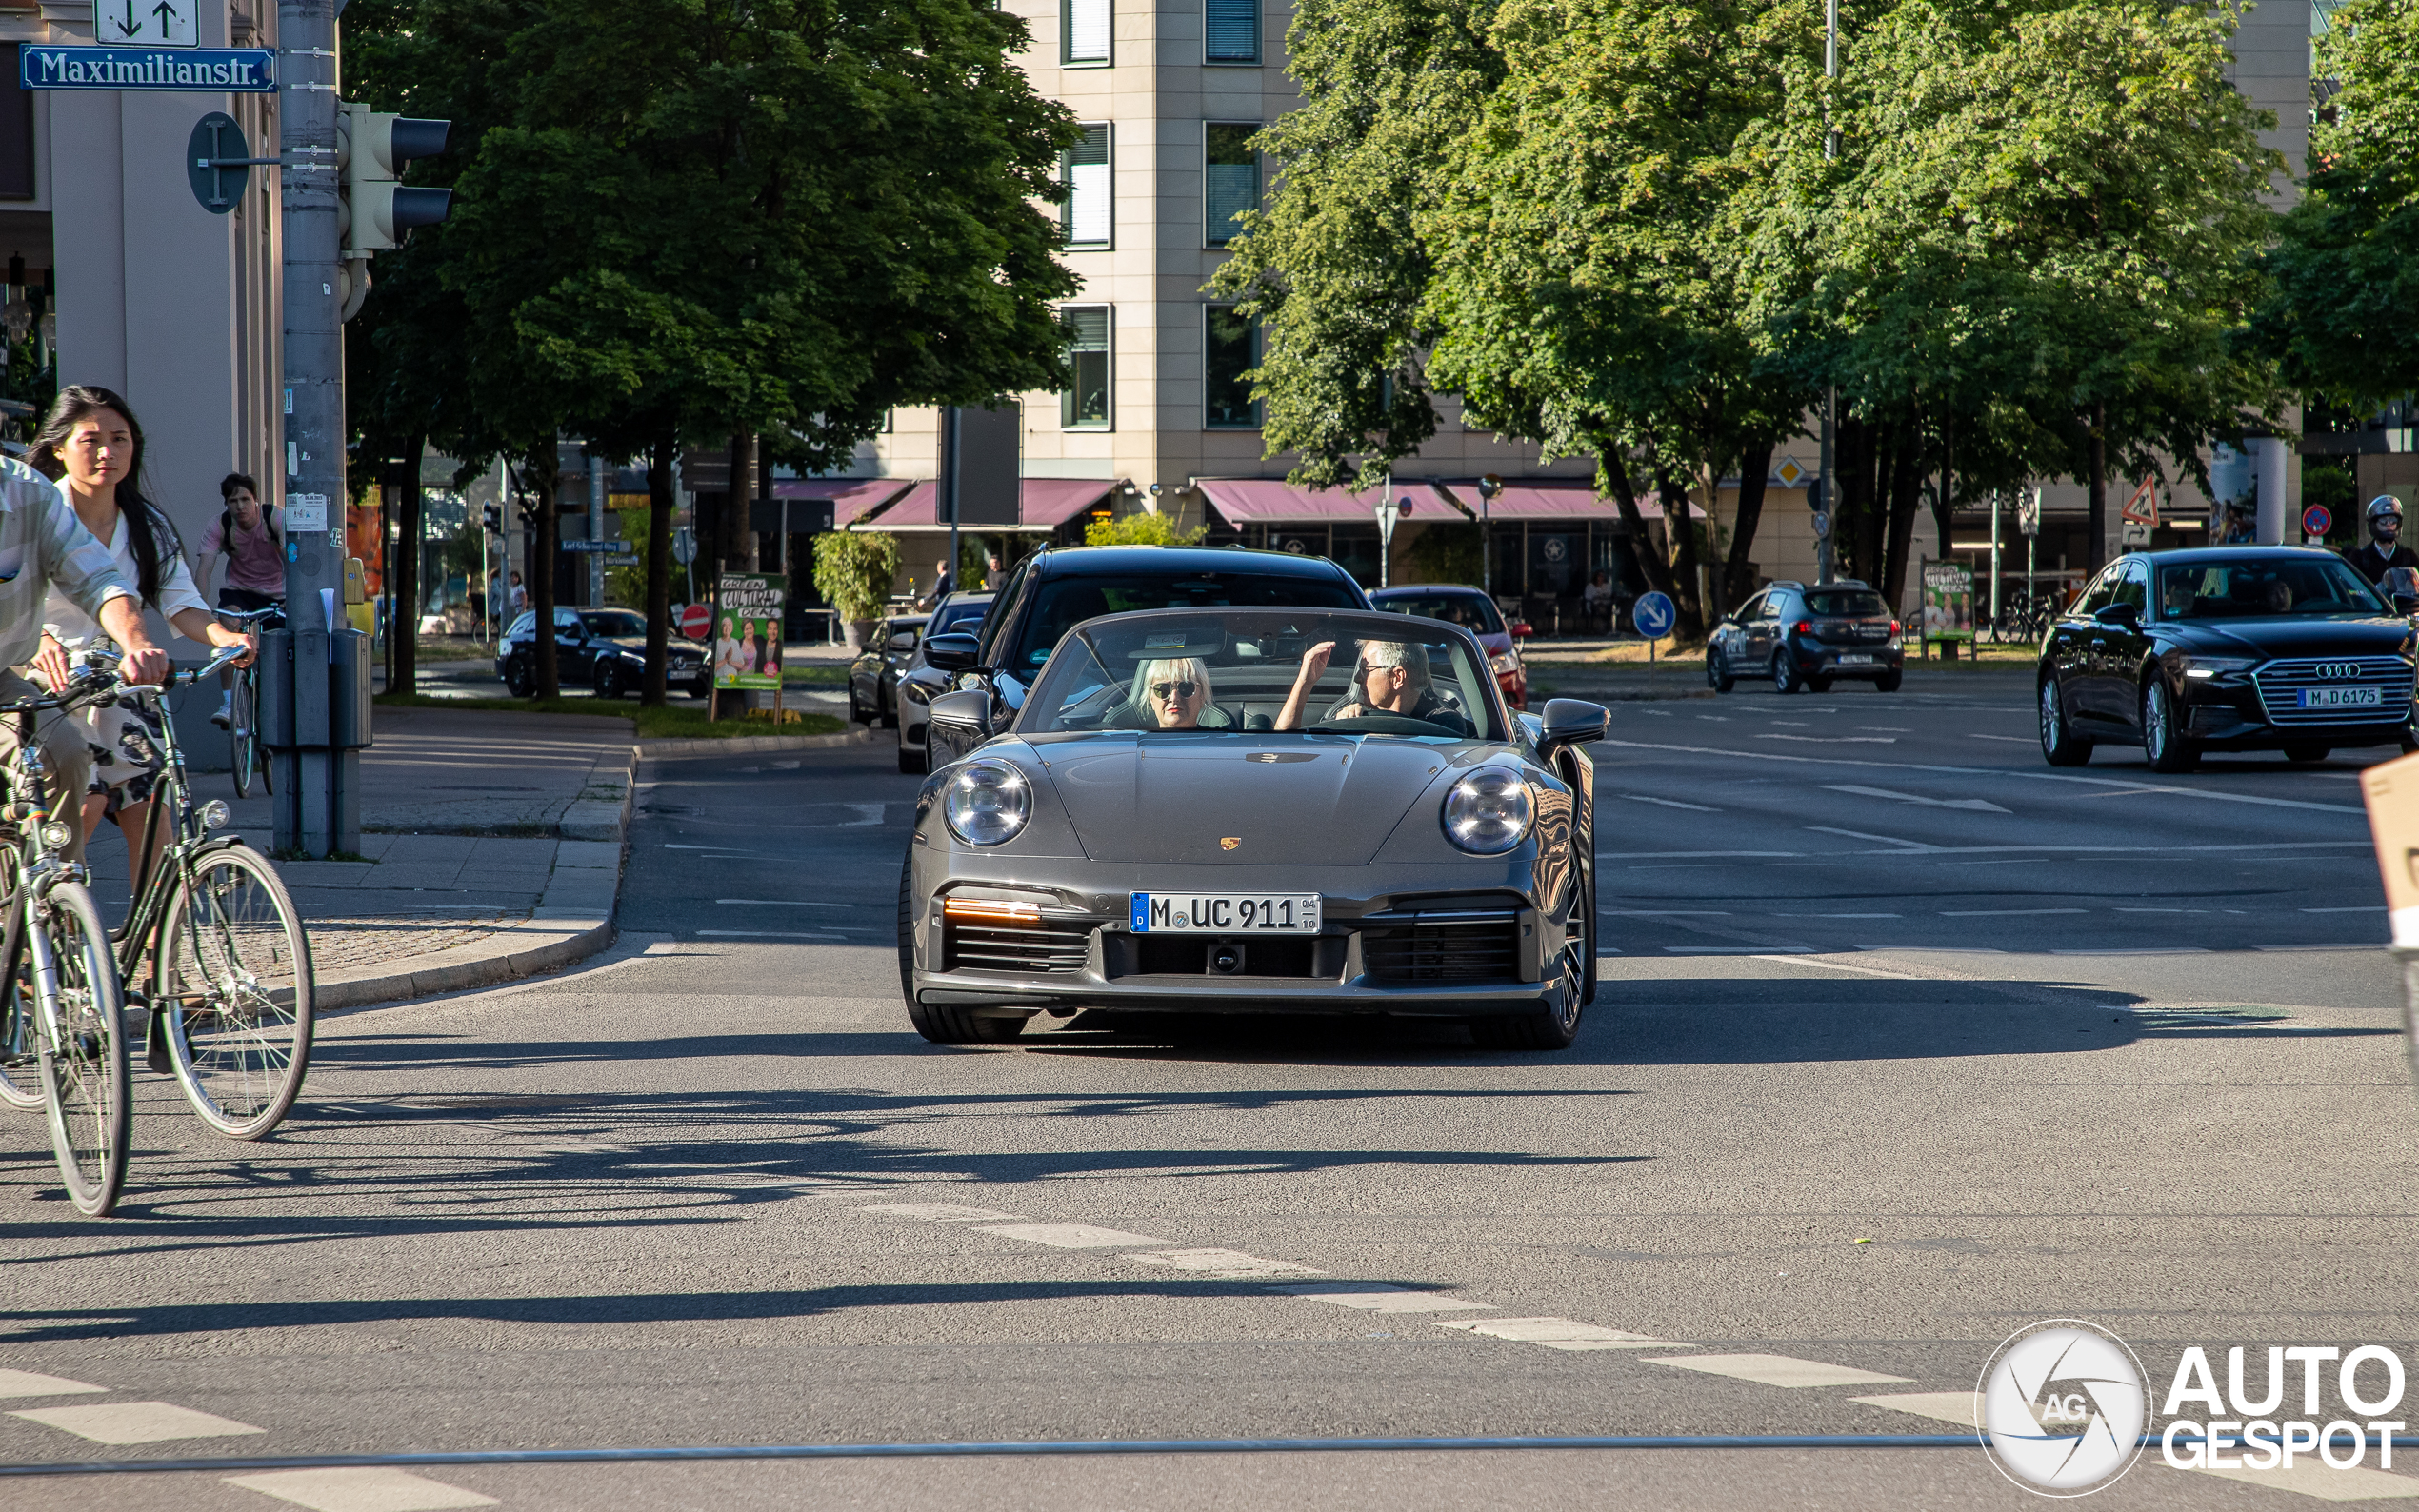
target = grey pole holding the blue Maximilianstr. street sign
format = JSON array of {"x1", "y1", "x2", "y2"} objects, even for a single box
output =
[{"x1": 273, "y1": 0, "x2": 352, "y2": 856}]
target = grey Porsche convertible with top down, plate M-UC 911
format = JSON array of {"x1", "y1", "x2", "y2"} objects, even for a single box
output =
[{"x1": 897, "y1": 607, "x2": 1607, "y2": 1050}]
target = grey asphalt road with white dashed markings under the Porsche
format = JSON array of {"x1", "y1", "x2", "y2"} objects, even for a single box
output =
[{"x1": 0, "y1": 680, "x2": 2419, "y2": 1509}]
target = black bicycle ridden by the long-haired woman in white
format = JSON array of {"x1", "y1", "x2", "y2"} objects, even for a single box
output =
[{"x1": 113, "y1": 648, "x2": 314, "y2": 1140}]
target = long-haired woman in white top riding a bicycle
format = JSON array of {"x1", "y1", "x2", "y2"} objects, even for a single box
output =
[{"x1": 29, "y1": 385, "x2": 254, "y2": 881}]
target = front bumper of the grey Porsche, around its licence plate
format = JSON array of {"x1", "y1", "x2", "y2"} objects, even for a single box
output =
[{"x1": 912, "y1": 845, "x2": 1577, "y2": 1019}]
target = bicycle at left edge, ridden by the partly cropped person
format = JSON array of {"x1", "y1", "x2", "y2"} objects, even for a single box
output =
[{"x1": 0, "y1": 672, "x2": 133, "y2": 1217}]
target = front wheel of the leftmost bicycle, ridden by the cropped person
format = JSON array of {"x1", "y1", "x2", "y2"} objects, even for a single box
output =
[{"x1": 27, "y1": 883, "x2": 133, "y2": 1217}]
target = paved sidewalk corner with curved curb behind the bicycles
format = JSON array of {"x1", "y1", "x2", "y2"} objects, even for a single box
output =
[{"x1": 92, "y1": 708, "x2": 636, "y2": 1009}]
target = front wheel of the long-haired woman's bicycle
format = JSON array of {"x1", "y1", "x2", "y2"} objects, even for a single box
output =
[{"x1": 152, "y1": 845, "x2": 312, "y2": 1140}]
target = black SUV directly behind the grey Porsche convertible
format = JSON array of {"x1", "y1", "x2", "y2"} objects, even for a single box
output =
[{"x1": 922, "y1": 547, "x2": 1369, "y2": 769}]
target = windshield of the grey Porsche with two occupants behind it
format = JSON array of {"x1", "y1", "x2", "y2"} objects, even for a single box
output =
[{"x1": 1016, "y1": 609, "x2": 1502, "y2": 740}]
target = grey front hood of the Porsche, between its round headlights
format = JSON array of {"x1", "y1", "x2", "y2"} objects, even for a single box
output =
[{"x1": 1038, "y1": 735, "x2": 1454, "y2": 866}]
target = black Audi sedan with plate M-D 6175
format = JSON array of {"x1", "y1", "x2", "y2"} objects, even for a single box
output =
[{"x1": 2037, "y1": 547, "x2": 2419, "y2": 772}]
